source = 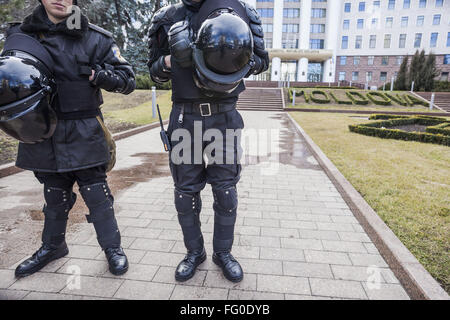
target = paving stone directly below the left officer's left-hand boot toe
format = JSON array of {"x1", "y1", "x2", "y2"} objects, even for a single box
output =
[{"x1": 9, "y1": 272, "x2": 70, "y2": 292}]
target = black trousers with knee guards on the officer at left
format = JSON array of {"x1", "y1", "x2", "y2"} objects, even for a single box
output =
[{"x1": 34, "y1": 166, "x2": 120, "y2": 250}]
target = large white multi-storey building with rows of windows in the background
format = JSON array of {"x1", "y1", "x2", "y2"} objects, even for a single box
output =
[{"x1": 246, "y1": 0, "x2": 450, "y2": 86}]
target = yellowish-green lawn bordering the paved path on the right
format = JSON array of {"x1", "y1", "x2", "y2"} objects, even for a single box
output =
[{"x1": 291, "y1": 112, "x2": 450, "y2": 292}]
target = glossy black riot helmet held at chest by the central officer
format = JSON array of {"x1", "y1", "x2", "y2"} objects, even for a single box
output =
[{"x1": 193, "y1": 9, "x2": 253, "y2": 93}]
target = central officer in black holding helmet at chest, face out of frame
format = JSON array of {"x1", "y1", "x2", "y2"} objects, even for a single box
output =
[{"x1": 149, "y1": 0, "x2": 269, "y2": 282}]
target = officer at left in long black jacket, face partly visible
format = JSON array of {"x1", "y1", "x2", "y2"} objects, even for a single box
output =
[{"x1": 4, "y1": 0, "x2": 135, "y2": 277}]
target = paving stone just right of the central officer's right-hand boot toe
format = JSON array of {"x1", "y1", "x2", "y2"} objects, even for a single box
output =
[{"x1": 257, "y1": 274, "x2": 311, "y2": 295}]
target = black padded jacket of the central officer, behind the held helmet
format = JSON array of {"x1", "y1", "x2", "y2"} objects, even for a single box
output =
[{"x1": 148, "y1": 0, "x2": 269, "y2": 103}]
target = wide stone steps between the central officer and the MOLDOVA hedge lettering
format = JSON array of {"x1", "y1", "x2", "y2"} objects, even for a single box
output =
[{"x1": 237, "y1": 88, "x2": 283, "y2": 111}]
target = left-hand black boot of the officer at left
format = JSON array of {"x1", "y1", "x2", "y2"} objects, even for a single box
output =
[{"x1": 15, "y1": 241, "x2": 69, "y2": 278}]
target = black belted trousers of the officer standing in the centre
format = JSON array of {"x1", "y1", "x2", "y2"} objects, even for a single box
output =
[{"x1": 168, "y1": 104, "x2": 244, "y2": 252}]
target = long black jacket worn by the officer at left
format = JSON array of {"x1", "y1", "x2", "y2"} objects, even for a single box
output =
[{"x1": 7, "y1": 5, "x2": 134, "y2": 172}]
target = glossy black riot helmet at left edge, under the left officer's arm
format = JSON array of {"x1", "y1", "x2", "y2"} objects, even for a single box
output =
[{"x1": 0, "y1": 33, "x2": 57, "y2": 143}]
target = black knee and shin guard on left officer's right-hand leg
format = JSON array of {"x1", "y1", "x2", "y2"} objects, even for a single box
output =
[{"x1": 80, "y1": 182, "x2": 120, "y2": 249}]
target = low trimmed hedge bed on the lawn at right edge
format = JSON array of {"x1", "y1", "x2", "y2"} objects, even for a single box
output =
[{"x1": 349, "y1": 115, "x2": 450, "y2": 146}]
